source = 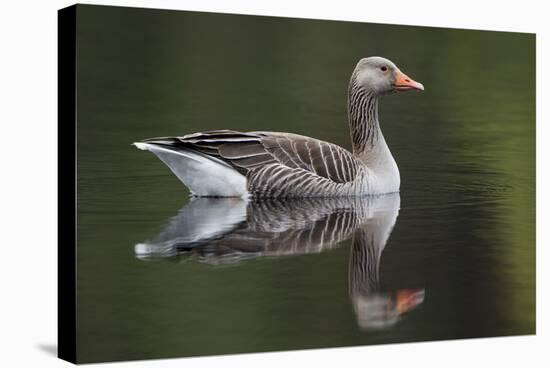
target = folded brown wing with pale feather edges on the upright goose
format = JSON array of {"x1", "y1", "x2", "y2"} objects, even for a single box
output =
[{"x1": 144, "y1": 130, "x2": 359, "y2": 183}]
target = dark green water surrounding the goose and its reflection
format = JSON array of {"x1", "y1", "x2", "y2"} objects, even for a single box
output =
[{"x1": 73, "y1": 6, "x2": 535, "y2": 362}]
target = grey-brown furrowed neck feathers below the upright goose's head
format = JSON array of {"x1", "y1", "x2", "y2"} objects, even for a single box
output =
[{"x1": 348, "y1": 78, "x2": 383, "y2": 155}]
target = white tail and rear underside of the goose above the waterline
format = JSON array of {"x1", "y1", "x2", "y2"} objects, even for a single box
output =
[{"x1": 134, "y1": 142, "x2": 248, "y2": 197}]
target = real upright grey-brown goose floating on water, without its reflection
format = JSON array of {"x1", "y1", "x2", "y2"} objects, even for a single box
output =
[{"x1": 134, "y1": 56, "x2": 424, "y2": 197}]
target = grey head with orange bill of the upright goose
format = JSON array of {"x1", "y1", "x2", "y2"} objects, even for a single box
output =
[{"x1": 352, "y1": 56, "x2": 424, "y2": 95}]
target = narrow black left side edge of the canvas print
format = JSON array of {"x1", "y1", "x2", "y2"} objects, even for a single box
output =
[{"x1": 57, "y1": 5, "x2": 76, "y2": 363}]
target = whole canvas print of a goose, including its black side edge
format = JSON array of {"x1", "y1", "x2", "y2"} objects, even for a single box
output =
[{"x1": 59, "y1": 5, "x2": 536, "y2": 363}]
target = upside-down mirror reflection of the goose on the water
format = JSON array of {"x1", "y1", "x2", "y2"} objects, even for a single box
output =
[{"x1": 135, "y1": 193, "x2": 424, "y2": 329}]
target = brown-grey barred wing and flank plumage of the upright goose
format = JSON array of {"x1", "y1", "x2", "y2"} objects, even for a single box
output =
[{"x1": 143, "y1": 130, "x2": 366, "y2": 197}]
